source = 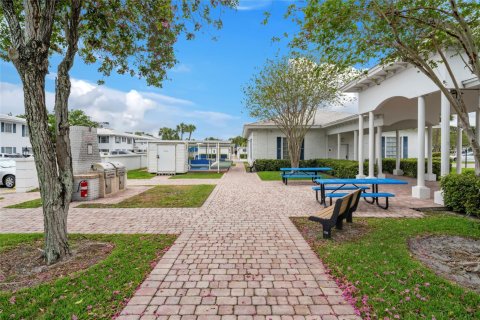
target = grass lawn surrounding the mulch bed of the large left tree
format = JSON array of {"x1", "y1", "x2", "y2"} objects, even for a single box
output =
[{"x1": 0, "y1": 234, "x2": 175, "y2": 319}]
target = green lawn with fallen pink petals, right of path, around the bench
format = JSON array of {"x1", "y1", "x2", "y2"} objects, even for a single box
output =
[{"x1": 292, "y1": 213, "x2": 480, "y2": 319}]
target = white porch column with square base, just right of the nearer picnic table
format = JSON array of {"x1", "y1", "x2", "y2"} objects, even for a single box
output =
[{"x1": 412, "y1": 97, "x2": 430, "y2": 199}]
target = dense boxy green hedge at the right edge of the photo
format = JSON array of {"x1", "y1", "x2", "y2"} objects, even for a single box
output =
[{"x1": 440, "y1": 172, "x2": 480, "y2": 217}]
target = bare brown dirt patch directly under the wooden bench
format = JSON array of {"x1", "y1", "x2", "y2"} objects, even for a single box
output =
[{"x1": 290, "y1": 217, "x2": 369, "y2": 245}]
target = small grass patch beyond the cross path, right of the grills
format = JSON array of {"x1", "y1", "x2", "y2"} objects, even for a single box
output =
[{"x1": 77, "y1": 184, "x2": 215, "y2": 208}]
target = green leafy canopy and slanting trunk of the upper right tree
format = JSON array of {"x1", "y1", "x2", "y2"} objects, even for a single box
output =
[{"x1": 288, "y1": 0, "x2": 480, "y2": 175}]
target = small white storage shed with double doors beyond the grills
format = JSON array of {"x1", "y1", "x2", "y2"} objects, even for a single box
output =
[{"x1": 147, "y1": 140, "x2": 188, "y2": 174}]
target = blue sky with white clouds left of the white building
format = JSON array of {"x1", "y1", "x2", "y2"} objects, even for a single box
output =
[{"x1": 0, "y1": 0, "x2": 302, "y2": 139}]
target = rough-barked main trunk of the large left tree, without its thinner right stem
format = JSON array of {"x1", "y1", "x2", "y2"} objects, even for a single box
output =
[{"x1": 22, "y1": 66, "x2": 71, "y2": 264}]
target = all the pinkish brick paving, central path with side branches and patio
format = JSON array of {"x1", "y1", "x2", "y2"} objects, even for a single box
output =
[{"x1": 0, "y1": 165, "x2": 442, "y2": 320}]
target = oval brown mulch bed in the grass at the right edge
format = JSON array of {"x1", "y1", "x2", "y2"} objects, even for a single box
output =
[{"x1": 408, "y1": 236, "x2": 480, "y2": 293}]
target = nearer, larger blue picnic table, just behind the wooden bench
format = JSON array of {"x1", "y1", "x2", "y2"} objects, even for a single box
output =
[{"x1": 314, "y1": 178, "x2": 408, "y2": 209}]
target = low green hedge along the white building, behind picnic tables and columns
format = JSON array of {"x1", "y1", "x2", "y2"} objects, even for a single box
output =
[{"x1": 255, "y1": 158, "x2": 451, "y2": 178}]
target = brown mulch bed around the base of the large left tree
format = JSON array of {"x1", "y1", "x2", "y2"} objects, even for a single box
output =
[{"x1": 0, "y1": 239, "x2": 114, "y2": 291}]
